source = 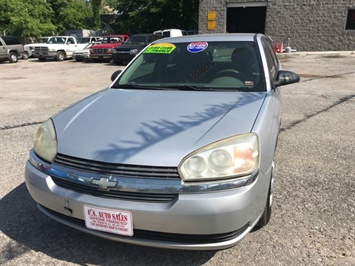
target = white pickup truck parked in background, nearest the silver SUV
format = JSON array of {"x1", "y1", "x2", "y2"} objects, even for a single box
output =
[{"x1": 33, "y1": 36, "x2": 86, "y2": 61}]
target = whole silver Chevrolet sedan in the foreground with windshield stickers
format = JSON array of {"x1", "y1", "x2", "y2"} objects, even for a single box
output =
[{"x1": 25, "y1": 34, "x2": 299, "y2": 250}]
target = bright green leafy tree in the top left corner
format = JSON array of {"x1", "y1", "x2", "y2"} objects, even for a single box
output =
[{"x1": 0, "y1": 0, "x2": 56, "y2": 38}]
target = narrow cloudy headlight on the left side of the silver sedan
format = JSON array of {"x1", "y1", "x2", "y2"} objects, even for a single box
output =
[{"x1": 33, "y1": 119, "x2": 57, "y2": 163}]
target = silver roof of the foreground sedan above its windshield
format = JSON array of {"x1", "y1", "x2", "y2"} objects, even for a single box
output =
[{"x1": 155, "y1": 33, "x2": 257, "y2": 43}]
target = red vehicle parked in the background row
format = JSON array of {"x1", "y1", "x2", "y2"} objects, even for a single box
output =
[{"x1": 90, "y1": 34, "x2": 129, "y2": 61}]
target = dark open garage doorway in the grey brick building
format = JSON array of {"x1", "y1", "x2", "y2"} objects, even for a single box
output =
[{"x1": 227, "y1": 6, "x2": 266, "y2": 33}]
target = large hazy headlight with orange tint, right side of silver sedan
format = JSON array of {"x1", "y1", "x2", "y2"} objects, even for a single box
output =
[{"x1": 178, "y1": 133, "x2": 260, "y2": 181}]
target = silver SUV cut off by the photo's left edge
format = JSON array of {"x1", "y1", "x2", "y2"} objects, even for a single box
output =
[{"x1": 0, "y1": 36, "x2": 23, "y2": 63}]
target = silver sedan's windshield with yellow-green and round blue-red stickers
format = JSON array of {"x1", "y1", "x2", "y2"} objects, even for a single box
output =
[{"x1": 112, "y1": 42, "x2": 266, "y2": 91}]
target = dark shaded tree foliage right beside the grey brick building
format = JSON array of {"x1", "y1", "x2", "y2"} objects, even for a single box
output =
[{"x1": 110, "y1": 0, "x2": 199, "y2": 33}]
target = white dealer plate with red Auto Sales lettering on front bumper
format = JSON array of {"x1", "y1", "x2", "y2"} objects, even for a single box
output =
[{"x1": 84, "y1": 205, "x2": 133, "y2": 236}]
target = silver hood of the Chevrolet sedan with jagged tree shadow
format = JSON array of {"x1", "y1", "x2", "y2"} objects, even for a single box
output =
[{"x1": 53, "y1": 89, "x2": 266, "y2": 166}]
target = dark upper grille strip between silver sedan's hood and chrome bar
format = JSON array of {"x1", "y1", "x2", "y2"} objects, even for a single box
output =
[{"x1": 54, "y1": 154, "x2": 180, "y2": 179}]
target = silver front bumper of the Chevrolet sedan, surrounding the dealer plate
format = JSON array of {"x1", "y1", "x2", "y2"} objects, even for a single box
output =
[{"x1": 25, "y1": 152, "x2": 268, "y2": 250}]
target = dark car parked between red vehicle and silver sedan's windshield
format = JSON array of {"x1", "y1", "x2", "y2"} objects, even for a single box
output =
[{"x1": 112, "y1": 33, "x2": 163, "y2": 65}]
